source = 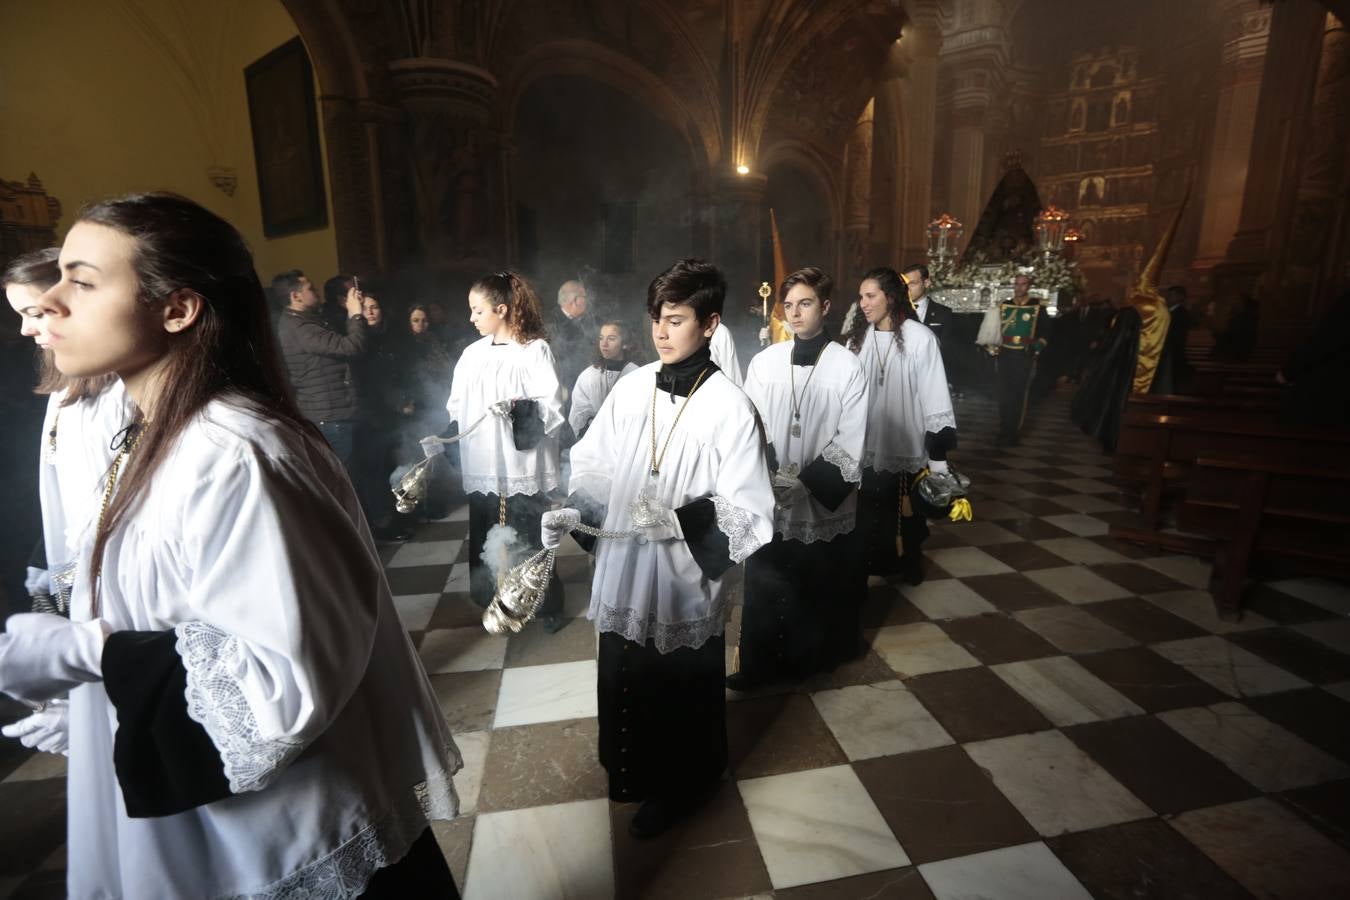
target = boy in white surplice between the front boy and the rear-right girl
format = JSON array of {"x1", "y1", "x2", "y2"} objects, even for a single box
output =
[{"x1": 726, "y1": 267, "x2": 868, "y2": 691}]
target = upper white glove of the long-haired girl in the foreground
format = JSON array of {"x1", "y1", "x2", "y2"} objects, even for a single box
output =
[{"x1": 0, "y1": 613, "x2": 112, "y2": 700}]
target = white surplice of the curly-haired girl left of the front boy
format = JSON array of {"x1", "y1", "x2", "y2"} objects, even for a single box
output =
[{"x1": 446, "y1": 336, "x2": 564, "y2": 497}]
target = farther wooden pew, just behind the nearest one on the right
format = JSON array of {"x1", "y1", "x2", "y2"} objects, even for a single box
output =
[{"x1": 1111, "y1": 405, "x2": 1350, "y2": 555}]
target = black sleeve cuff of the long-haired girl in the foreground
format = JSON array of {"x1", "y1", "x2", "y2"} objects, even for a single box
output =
[{"x1": 103, "y1": 631, "x2": 230, "y2": 819}]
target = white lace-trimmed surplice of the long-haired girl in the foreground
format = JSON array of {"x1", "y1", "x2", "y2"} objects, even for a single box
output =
[{"x1": 68, "y1": 399, "x2": 460, "y2": 900}]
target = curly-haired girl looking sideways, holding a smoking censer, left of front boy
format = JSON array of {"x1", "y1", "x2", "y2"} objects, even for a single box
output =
[{"x1": 423, "y1": 273, "x2": 567, "y2": 631}]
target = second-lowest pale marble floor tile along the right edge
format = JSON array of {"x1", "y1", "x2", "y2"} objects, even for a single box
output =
[{"x1": 1158, "y1": 702, "x2": 1350, "y2": 792}]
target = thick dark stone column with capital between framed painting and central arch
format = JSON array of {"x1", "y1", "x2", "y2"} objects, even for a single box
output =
[{"x1": 389, "y1": 57, "x2": 510, "y2": 274}]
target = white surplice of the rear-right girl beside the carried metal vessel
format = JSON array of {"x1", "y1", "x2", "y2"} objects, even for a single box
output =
[{"x1": 857, "y1": 318, "x2": 956, "y2": 472}]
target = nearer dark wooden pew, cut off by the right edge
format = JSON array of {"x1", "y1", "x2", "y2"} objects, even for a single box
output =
[{"x1": 1177, "y1": 456, "x2": 1350, "y2": 621}]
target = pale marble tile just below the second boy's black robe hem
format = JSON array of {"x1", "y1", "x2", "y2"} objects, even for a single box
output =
[{"x1": 811, "y1": 681, "x2": 953, "y2": 760}]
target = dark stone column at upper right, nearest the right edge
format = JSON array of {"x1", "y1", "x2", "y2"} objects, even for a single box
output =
[{"x1": 1212, "y1": 0, "x2": 1326, "y2": 304}]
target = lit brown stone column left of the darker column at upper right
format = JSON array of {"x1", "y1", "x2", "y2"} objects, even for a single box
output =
[{"x1": 1191, "y1": 0, "x2": 1270, "y2": 275}]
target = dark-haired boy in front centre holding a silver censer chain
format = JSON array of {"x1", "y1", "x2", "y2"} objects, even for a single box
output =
[{"x1": 543, "y1": 259, "x2": 774, "y2": 838}]
